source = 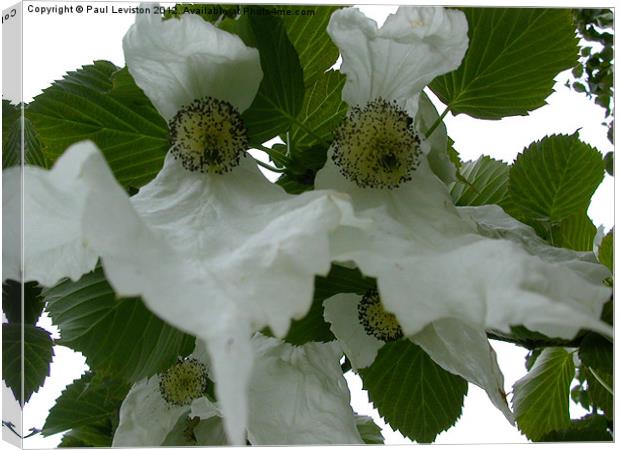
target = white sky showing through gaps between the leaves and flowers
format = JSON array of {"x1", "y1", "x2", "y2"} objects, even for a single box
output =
[{"x1": 2, "y1": 1, "x2": 614, "y2": 448}]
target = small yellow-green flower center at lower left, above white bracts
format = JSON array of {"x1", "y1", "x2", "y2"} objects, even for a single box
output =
[{"x1": 159, "y1": 358, "x2": 209, "y2": 406}]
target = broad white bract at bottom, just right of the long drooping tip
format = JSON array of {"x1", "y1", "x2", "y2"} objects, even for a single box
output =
[{"x1": 248, "y1": 335, "x2": 362, "y2": 445}]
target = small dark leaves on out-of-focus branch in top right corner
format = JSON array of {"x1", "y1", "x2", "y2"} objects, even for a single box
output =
[{"x1": 567, "y1": 9, "x2": 614, "y2": 142}]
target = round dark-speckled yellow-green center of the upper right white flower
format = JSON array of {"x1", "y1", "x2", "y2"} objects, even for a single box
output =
[{"x1": 332, "y1": 98, "x2": 421, "y2": 189}]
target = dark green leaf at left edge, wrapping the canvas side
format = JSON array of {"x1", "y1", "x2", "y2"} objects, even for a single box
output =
[{"x1": 2, "y1": 100, "x2": 48, "y2": 169}]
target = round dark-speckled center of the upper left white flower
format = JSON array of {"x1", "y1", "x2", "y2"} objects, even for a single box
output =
[{"x1": 169, "y1": 97, "x2": 249, "y2": 174}]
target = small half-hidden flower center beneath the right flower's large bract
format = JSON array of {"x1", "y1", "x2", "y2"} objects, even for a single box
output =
[{"x1": 357, "y1": 289, "x2": 403, "y2": 342}]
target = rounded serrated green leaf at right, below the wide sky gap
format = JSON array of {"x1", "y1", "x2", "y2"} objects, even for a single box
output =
[{"x1": 509, "y1": 135, "x2": 604, "y2": 222}]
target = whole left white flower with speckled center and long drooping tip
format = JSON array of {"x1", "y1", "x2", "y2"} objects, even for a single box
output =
[{"x1": 3, "y1": 6, "x2": 366, "y2": 444}]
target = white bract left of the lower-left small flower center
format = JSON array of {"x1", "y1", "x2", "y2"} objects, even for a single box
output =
[{"x1": 112, "y1": 376, "x2": 189, "y2": 447}]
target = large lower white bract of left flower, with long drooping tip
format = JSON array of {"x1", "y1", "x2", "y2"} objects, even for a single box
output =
[{"x1": 21, "y1": 144, "x2": 355, "y2": 444}]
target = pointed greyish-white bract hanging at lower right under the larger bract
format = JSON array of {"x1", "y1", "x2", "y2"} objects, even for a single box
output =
[{"x1": 410, "y1": 319, "x2": 514, "y2": 424}]
